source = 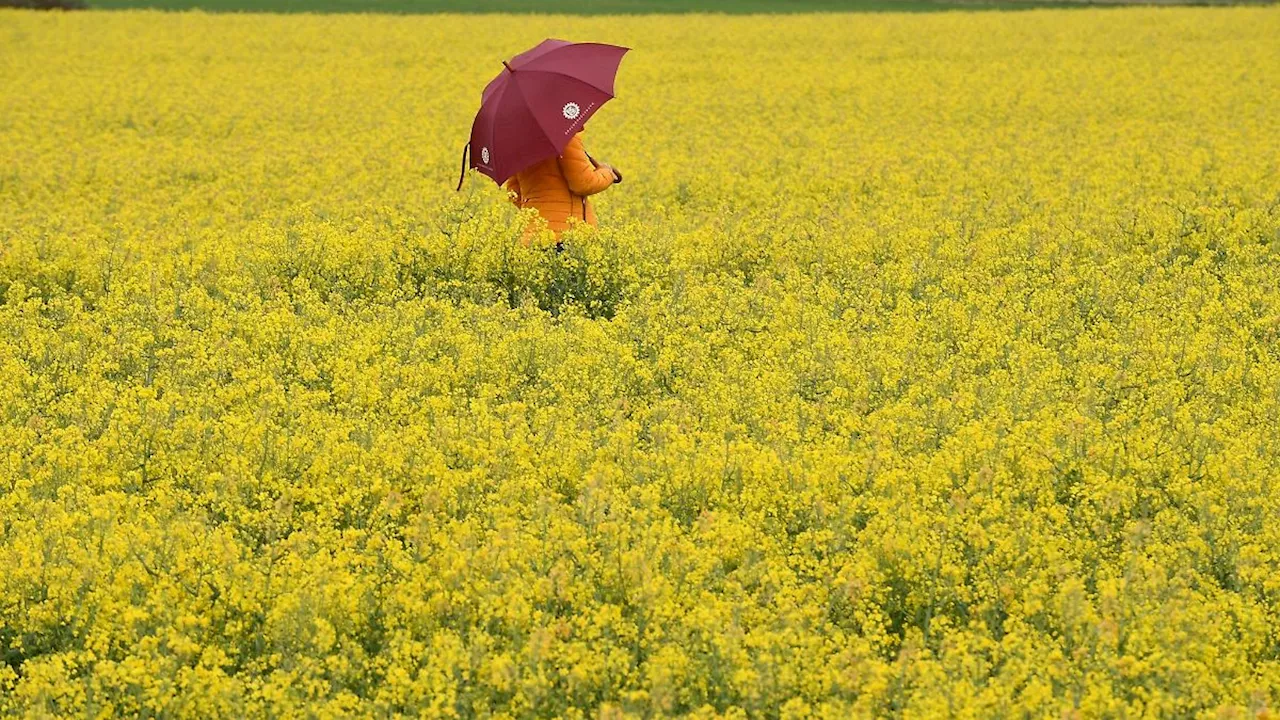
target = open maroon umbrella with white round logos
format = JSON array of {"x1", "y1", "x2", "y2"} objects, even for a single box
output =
[{"x1": 458, "y1": 40, "x2": 630, "y2": 190}]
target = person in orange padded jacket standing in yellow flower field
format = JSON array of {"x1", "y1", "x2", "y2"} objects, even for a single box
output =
[{"x1": 506, "y1": 132, "x2": 622, "y2": 245}]
